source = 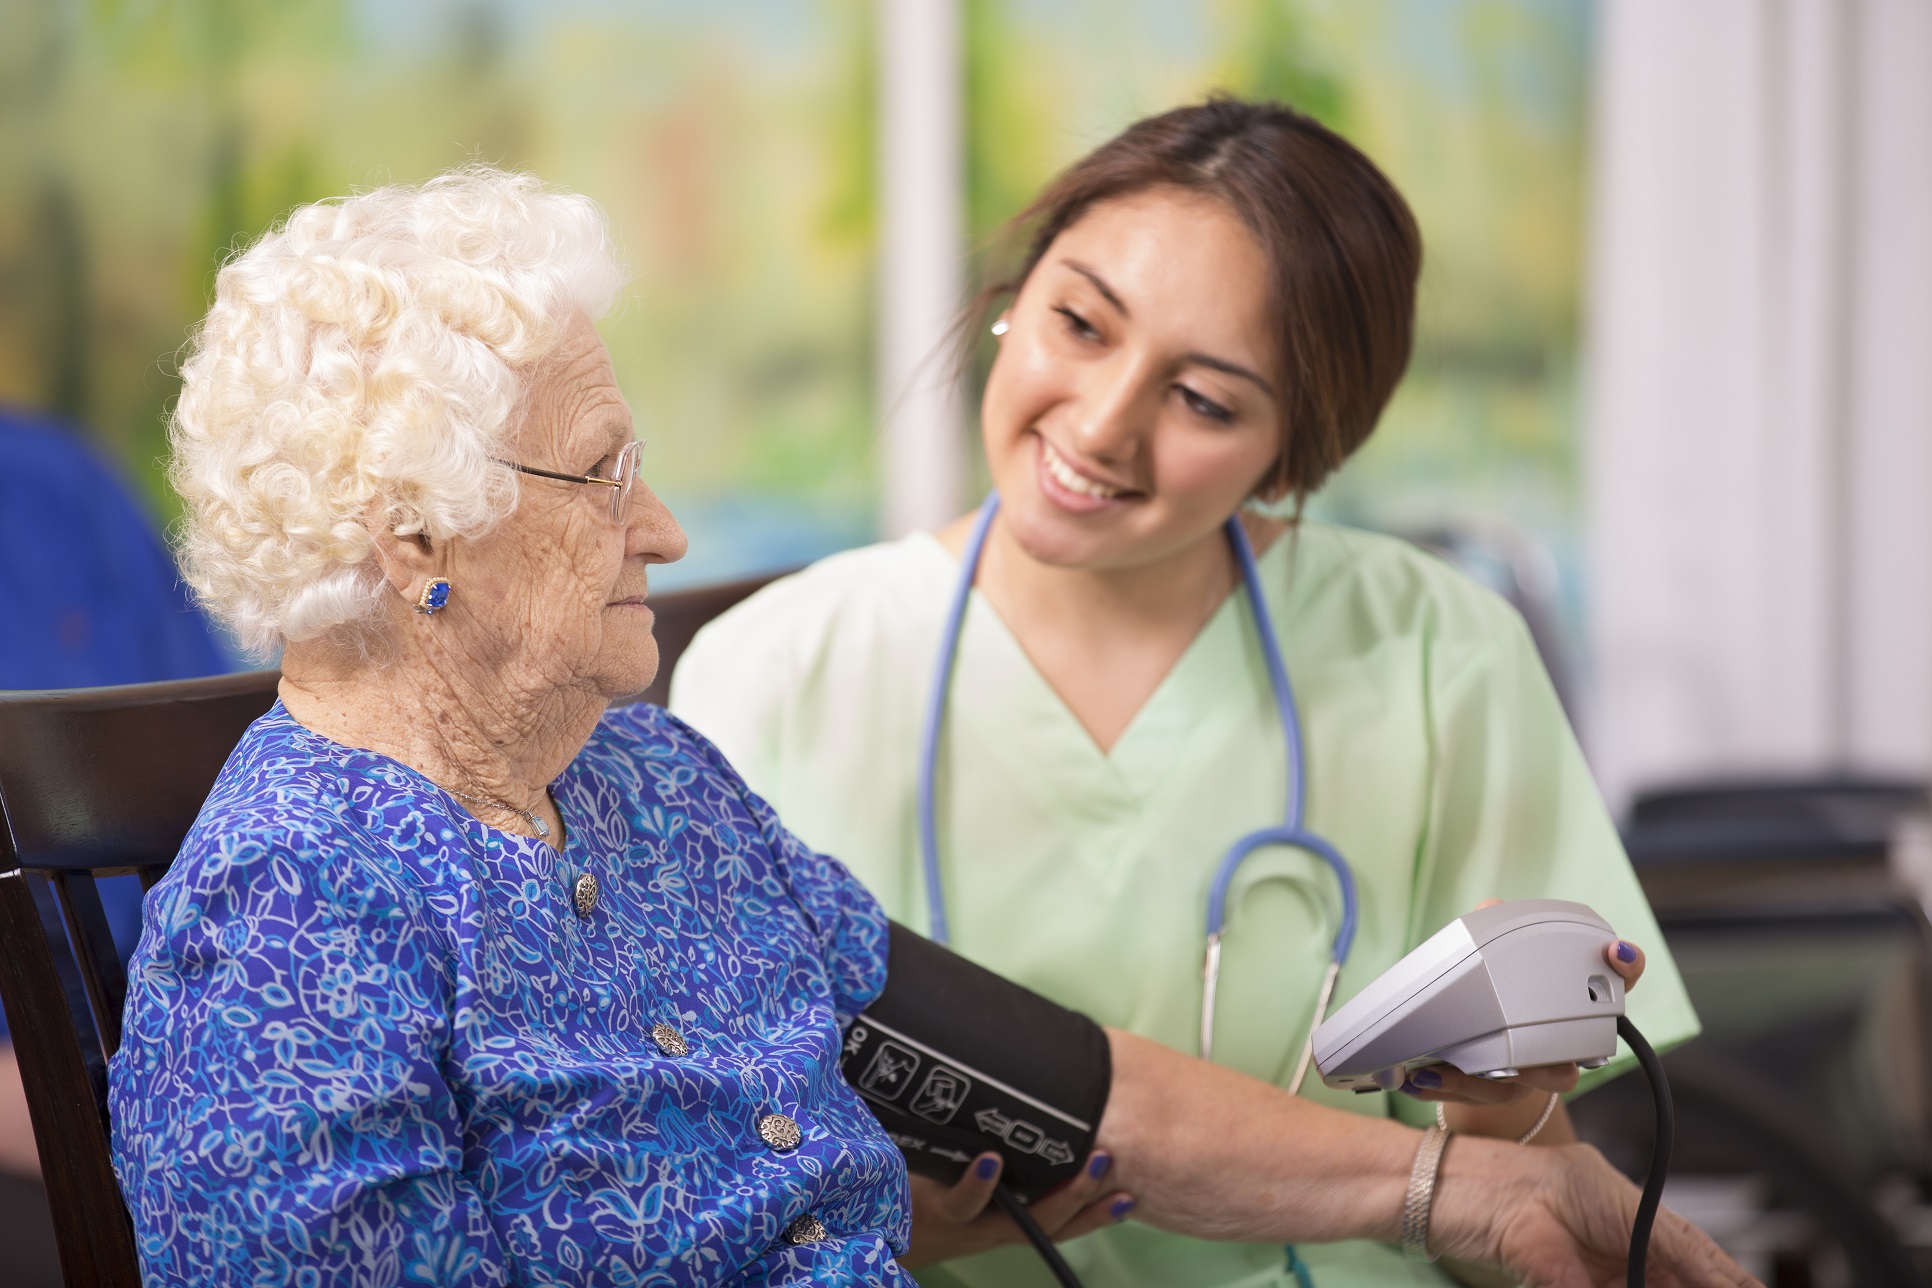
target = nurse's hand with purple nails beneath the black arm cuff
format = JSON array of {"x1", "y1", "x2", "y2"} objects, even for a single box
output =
[{"x1": 898, "y1": 1151, "x2": 1134, "y2": 1271}]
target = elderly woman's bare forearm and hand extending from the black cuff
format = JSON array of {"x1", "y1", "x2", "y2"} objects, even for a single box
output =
[{"x1": 1099, "y1": 1029, "x2": 1752, "y2": 1288}]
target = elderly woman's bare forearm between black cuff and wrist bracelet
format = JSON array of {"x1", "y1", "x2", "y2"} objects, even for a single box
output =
[{"x1": 1099, "y1": 1029, "x2": 1468, "y2": 1242}]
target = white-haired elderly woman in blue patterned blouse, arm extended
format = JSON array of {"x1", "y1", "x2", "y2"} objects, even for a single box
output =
[{"x1": 110, "y1": 170, "x2": 1743, "y2": 1284}]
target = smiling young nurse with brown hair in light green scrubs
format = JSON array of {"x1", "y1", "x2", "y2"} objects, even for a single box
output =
[{"x1": 672, "y1": 98, "x2": 1696, "y2": 1288}]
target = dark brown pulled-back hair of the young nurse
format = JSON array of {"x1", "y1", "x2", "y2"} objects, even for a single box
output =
[{"x1": 964, "y1": 97, "x2": 1422, "y2": 496}]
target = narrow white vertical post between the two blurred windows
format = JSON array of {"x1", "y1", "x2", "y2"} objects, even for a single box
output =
[{"x1": 877, "y1": 0, "x2": 966, "y2": 537}]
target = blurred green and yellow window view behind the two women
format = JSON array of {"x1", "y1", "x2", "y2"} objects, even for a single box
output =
[{"x1": 0, "y1": 0, "x2": 1590, "y2": 585}]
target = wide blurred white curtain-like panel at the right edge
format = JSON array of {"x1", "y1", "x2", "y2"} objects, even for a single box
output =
[{"x1": 1586, "y1": 0, "x2": 1932, "y2": 803}]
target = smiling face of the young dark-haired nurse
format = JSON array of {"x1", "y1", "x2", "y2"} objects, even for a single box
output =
[{"x1": 981, "y1": 187, "x2": 1281, "y2": 568}]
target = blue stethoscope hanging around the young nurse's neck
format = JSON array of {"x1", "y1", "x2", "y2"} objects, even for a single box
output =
[{"x1": 918, "y1": 492, "x2": 1356, "y2": 1095}]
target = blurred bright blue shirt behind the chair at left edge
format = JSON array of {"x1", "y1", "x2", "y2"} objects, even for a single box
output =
[{"x1": 0, "y1": 407, "x2": 232, "y2": 1039}]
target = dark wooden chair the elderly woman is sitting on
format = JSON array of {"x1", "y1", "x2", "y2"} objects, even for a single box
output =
[{"x1": 0, "y1": 575, "x2": 773, "y2": 1288}]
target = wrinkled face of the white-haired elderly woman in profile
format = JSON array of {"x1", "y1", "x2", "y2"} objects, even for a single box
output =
[{"x1": 448, "y1": 315, "x2": 686, "y2": 697}]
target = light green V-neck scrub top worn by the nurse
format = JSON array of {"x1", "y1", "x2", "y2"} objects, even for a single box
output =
[{"x1": 670, "y1": 523, "x2": 1698, "y2": 1288}]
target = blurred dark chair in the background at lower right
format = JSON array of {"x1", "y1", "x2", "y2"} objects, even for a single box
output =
[{"x1": 1573, "y1": 778, "x2": 1932, "y2": 1288}]
